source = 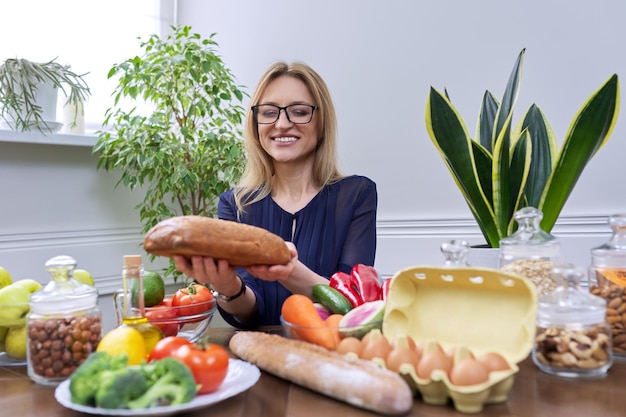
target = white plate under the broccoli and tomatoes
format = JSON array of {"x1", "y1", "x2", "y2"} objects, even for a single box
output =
[{"x1": 54, "y1": 359, "x2": 261, "y2": 417}]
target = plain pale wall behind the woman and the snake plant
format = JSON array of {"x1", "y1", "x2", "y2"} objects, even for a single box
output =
[{"x1": 177, "y1": 0, "x2": 626, "y2": 273}]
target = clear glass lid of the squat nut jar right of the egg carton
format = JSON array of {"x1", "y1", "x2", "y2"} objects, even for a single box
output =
[{"x1": 537, "y1": 264, "x2": 606, "y2": 327}]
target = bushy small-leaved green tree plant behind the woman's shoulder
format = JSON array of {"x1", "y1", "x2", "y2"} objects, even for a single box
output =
[{"x1": 93, "y1": 26, "x2": 247, "y2": 273}]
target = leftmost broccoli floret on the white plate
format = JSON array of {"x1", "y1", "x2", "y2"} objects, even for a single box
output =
[{"x1": 70, "y1": 352, "x2": 128, "y2": 406}]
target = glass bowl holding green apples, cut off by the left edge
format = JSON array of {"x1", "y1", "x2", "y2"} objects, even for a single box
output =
[{"x1": 0, "y1": 302, "x2": 30, "y2": 366}]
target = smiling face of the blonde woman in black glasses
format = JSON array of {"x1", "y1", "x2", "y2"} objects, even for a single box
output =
[{"x1": 258, "y1": 75, "x2": 320, "y2": 164}]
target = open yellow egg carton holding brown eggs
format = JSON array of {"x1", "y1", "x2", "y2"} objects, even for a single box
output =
[{"x1": 377, "y1": 266, "x2": 537, "y2": 413}]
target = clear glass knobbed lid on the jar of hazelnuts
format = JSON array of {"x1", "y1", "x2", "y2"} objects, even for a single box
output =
[{"x1": 30, "y1": 255, "x2": 98, "y2": 314}]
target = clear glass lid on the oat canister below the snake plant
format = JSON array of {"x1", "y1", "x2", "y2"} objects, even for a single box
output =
[{"x1": 500, "y1": 207, "x2": 561, "y2": 265}]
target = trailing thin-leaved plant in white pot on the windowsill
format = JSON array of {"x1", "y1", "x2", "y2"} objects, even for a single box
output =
[{"x1": 0, "y1": 58, "x2": 91, "y2": 134}]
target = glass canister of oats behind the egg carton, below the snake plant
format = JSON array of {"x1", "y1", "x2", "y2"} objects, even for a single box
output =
[{"x1": 498, "y1": 207, "x2": 561, "y2": 296}]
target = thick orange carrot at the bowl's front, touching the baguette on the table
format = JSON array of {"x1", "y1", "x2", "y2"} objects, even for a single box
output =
[{"x1": 281, "y1": 294, "x2": 335, "y2": 349}]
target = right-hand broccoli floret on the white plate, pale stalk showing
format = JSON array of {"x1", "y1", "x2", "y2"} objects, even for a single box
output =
[{"x1": 127, "y1": 357, "x2": 198, "y2": 409}]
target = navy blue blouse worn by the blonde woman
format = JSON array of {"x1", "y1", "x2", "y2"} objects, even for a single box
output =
[{"x1": 218, "y1": 175, "x2": 378, "y2": 328}]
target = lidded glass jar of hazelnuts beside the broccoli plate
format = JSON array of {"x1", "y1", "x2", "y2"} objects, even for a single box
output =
[{"x1": 26, "y1": 256, "x2": 102, "y2": 385}]
